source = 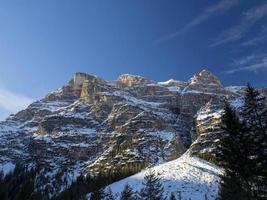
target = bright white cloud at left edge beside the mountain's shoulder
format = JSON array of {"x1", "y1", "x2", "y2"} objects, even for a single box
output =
[{"x1": 0, "y1": 88, "x2": 33, "y2": 113}]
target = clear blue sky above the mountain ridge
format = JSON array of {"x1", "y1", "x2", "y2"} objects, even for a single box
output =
[{"x1": 0, "y1": 0, "x2": 267, "y2": 119}]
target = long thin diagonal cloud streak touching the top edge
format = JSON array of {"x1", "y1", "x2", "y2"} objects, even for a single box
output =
[{"x1": 155, "y1": 0, "x2": 239, "y2": 44}]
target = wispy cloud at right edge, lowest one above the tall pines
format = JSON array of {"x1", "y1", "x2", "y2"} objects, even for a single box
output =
[{"x1": 225, "y1": 54, "x2": 267, "y2": 74}]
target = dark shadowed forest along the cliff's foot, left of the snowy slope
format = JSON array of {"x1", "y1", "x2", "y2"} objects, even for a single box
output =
[{"x1": 0, "y1": 163, "x2": 147, "y2": 200}]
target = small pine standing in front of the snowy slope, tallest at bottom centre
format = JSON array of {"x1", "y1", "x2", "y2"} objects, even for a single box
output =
[{"x1": 139, "y1": 169, "x2": 166, "y2": 200}]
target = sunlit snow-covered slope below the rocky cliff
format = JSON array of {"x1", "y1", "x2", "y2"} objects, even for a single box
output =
[{"x1": 107, "y1": 153, "x2": 222, "y2": 200}]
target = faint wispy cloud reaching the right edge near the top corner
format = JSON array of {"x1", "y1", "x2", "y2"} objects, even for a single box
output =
[{"x1": 210, "y1": 3, "x2": 267, "y2": 47}]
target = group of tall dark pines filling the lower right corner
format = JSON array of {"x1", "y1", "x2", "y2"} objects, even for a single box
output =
[{"x1": 216, "y1": 85, "x2": 267, "y2": 200}]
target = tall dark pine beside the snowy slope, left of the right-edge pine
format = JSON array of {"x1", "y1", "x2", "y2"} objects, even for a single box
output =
[{"x1": 217, "y1": 104, "x2": 252, "y2": 200}]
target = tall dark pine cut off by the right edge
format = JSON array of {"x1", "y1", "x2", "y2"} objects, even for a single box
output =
[{"x1": 242, "y1": 84, "x2": 267, "y2": 199}]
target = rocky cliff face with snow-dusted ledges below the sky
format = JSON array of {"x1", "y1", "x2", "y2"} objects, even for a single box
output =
[{"x1": 0, "y1": 70, "x2": 266, "y2": 197}]
